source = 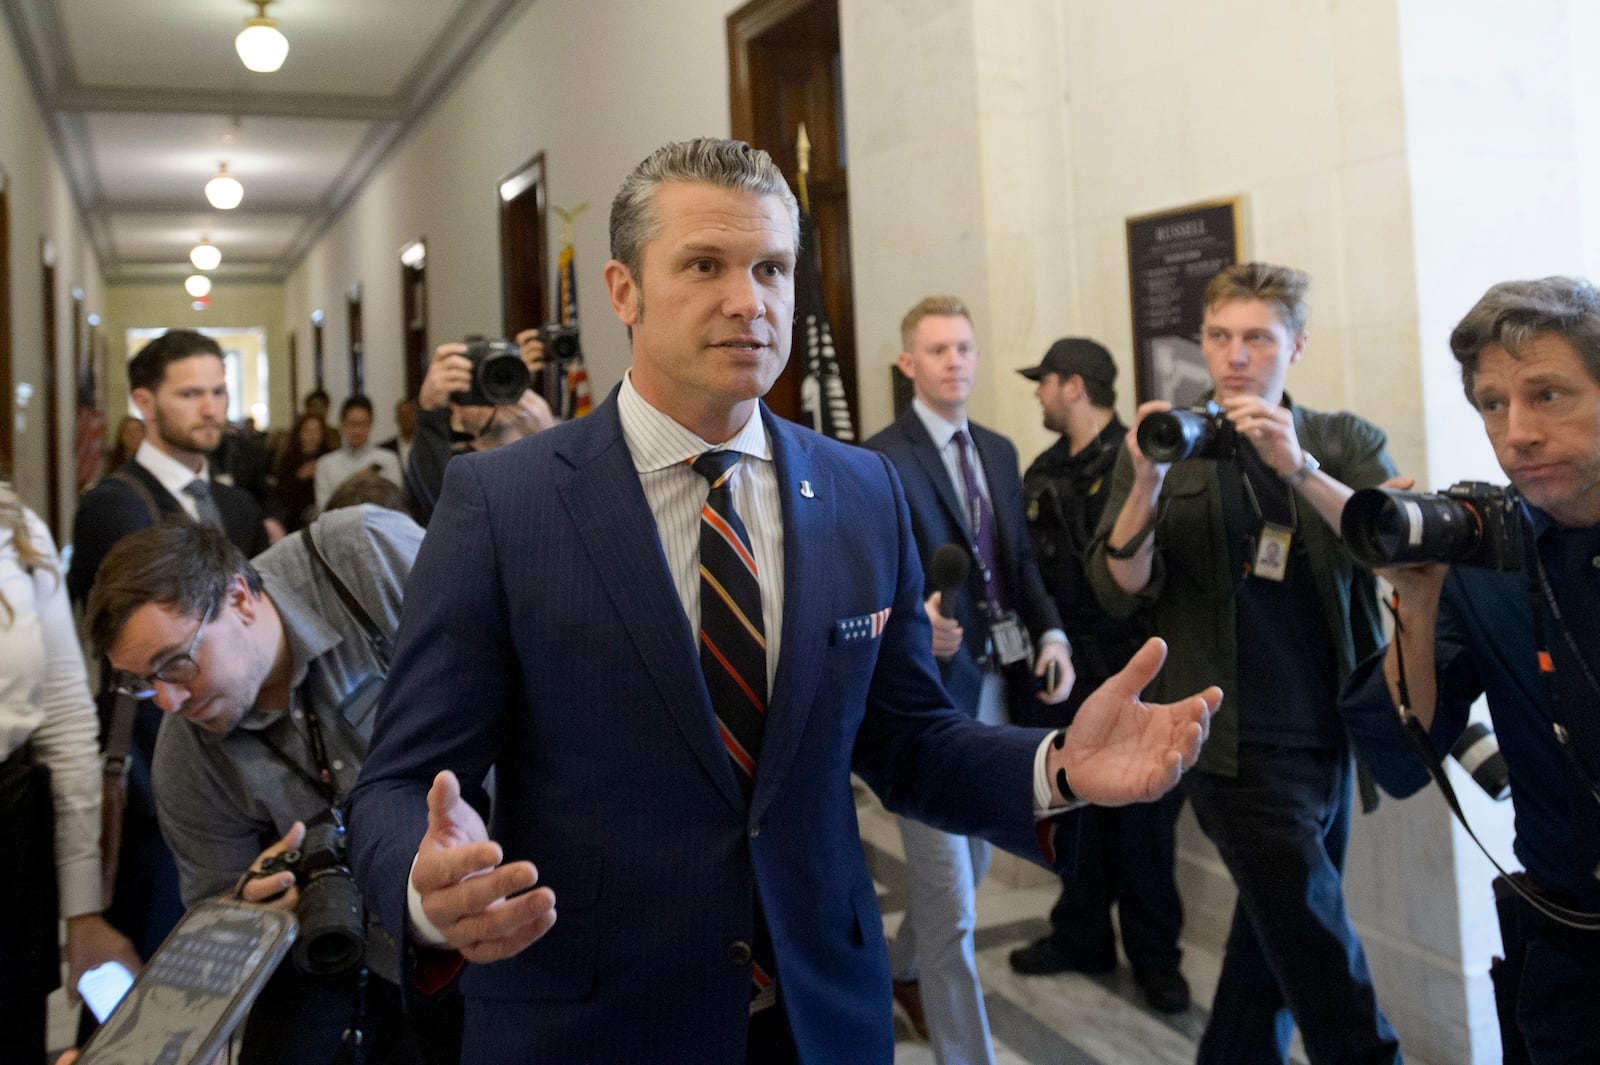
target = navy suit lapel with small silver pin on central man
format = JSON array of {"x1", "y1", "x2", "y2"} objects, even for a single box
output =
[{"x1": 750, "y1": 405, "x2": 843, "y2": 819}]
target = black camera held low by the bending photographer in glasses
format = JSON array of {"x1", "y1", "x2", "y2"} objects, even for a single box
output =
[{"x1": 259, "y1": 809, "x2": 366, "y2": 975}]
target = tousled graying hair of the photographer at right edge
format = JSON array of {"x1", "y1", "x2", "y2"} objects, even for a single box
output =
[{"x1": 1450, "y1": 277, "x2": 1600, "y2": 406}]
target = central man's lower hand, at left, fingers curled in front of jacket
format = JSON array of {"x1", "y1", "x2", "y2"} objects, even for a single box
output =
[{"x1": 411, "y1": 771, "x2": 555, "y2": 961}]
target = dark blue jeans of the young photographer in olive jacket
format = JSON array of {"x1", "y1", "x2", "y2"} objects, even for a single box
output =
[{"x1": 1184, "y1": 744, "x2": 1402, "y2": 1065}]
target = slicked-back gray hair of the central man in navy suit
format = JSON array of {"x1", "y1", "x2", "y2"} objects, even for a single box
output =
[{"x1": 611, "y1": 138, "x2": 800, "y2": 278}]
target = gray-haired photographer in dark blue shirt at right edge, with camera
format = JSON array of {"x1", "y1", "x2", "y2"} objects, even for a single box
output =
[{"x1": 1341, "y1": 277, "x2": 1600, "y2": 1063}]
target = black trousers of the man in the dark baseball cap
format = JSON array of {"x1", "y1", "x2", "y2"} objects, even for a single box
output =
[{"x1": 1050, "y1": 790, "x2": 1184, "y2": 975}]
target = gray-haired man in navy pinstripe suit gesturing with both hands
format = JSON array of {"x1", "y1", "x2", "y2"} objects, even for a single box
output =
[{"x1": 350, "y1": 139, "x2": 1221, "y2": 1065}]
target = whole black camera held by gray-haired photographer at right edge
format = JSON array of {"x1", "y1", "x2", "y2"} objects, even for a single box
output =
[{"x1": 1339, "y1": 481, "x2": 1523, "y2": 569}]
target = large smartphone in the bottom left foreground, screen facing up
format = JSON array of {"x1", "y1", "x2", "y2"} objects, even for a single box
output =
[{"x1": 78, "y1": 899, "x2": 296, "y2": 1065}]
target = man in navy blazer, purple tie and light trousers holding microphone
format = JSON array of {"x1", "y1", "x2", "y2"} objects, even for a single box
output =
[{"x1": 867, "y1": 296, "x2": 1074, "y2": 1065}]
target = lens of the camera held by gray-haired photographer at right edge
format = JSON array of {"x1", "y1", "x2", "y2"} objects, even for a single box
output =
[{"x1": 1339, "y1": 488, "x2": 1483, "y2": 566}]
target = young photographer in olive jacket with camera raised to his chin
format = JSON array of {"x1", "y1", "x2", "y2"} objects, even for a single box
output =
[{"x1": 1086, "y1": 262, "x2": 1400, "y2": 1065}]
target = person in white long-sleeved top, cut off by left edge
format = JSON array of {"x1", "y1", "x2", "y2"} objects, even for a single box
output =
[{"x1": 0, "y1": 481, "x2": 139, "y2": 1062}]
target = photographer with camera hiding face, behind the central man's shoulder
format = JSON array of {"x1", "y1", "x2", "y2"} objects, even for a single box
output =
[{"x1": 405, "y1": 326, "x2": 560, "y2": 525}]
